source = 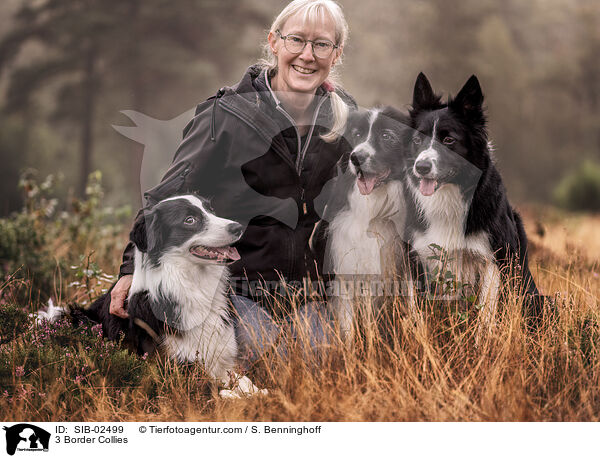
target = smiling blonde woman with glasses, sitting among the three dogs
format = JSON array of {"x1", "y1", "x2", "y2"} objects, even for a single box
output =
[{"x1": 110, "y1": 0, "x2": 355, "y2": 354}]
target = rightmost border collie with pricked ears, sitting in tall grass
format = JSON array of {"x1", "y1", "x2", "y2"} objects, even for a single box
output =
[{"x1": 407, "y1": 73, "x2": 540, "y2": 330}]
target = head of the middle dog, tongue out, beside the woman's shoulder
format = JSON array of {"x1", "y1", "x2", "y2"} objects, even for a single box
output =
[{"x1": 346, "y1": 107, "x2": 409, "y2": 195}]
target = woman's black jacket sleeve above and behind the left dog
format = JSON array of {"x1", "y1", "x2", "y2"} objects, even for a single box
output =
[{"x1": 119, "y1": 98, "x2": 230, "y2": 278}]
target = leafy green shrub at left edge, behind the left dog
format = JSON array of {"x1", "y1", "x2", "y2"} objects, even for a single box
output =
[{"x1": 0, "y1": 170, "x2": 131, "y2": 304}]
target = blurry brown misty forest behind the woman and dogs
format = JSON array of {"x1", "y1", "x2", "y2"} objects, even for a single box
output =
[{"x1": 0, "y1": 0, "x2": 600, "y2": 216}]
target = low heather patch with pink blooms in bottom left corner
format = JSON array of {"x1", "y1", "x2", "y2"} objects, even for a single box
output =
[{"x1": 0, "y1": 306, "x2": 149, "y2": 415}]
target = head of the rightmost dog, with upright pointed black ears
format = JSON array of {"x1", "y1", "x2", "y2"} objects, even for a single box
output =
[{"x1": 410, "y1": 73, "x2": 489, "y2": 196}]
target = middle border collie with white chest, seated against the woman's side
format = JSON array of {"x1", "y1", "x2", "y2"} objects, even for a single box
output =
[{"x1": 326, "y1": 107, "x2": 418, "y2": 341}]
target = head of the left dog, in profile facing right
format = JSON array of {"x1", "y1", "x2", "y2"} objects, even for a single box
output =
[{"x1": 130, "y1": 195, "x2": 243, "y2": 265}]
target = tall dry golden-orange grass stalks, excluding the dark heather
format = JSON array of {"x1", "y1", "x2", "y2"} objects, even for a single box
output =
[{"x1": 0, "y1": 206, "x2": 600, "y2": 421}]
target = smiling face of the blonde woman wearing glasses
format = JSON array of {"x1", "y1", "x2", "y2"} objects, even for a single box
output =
[{"x1": 268, "y1": 13, "x2": 341, "y2": 94}]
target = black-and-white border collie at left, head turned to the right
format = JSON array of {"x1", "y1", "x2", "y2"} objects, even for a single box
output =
[{"x1": 46, "y1": 195, "x2": 266, "y2": 397}]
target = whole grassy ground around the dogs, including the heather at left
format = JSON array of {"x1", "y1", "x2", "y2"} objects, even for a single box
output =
[{"x1": 0, "y1": 208, "x2": 600, "y2": 421}]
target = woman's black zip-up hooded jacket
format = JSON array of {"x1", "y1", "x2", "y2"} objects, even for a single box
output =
[{"x1": 120, "y1": 66, "x2": 356, "y2": 295}]
